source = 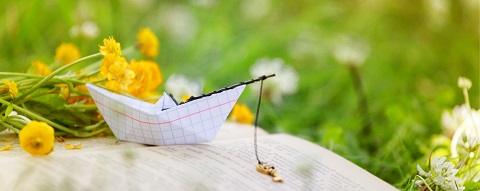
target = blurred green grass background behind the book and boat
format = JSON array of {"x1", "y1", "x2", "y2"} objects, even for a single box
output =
[{"x1": 0, "y1": 0, "x2": 480, "y2": 187}]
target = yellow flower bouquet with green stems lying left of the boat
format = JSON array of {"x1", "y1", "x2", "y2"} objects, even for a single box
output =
[{"x1": 0, "y1": 28, "x2": 163, "y2": 155}]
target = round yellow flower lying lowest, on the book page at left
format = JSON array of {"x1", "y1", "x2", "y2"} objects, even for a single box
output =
[{"x1": 18, "y1": 121, "x2": 55, "y2": 156}]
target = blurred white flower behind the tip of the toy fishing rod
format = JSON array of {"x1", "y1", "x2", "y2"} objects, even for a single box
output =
[{"x1": 250, "y1": 58, "x2": 298, "y2": 104}]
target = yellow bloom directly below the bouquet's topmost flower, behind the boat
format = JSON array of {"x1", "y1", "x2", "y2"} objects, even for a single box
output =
[{"x1": 128, "y1": 60, "x2": 163, "y2": 98}]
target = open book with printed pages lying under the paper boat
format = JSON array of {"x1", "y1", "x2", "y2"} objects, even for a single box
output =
[{"x1": 0, "y1": 123, "x2": 396, "y2": 191}]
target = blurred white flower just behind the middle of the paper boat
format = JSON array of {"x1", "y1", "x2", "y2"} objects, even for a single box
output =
[{"x1": 165, "y1": 74, "x2": 202, "y2": 101}]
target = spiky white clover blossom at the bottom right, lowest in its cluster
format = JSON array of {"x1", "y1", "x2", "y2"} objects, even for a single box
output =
[{"x1": 415, "y1": 156, "x2": 465, "y2": 191}]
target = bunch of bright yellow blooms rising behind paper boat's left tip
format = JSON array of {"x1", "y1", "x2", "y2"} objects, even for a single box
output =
[{"x1": 99, "y1": 28, "x2": 163, "y2": 98}]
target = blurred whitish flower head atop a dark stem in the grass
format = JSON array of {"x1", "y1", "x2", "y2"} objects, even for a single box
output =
[{"x1": 333, "y1": 36, "x2": 370, "y2": 67}]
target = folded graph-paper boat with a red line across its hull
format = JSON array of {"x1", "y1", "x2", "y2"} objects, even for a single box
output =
[{"x1": 87, "y1": 84, "x2": 245, "y2": 145}]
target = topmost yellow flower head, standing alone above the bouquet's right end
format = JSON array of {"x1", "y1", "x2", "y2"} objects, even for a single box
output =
[{"x1": 137, "y1": 28, "x2": 160, "y2": 58}]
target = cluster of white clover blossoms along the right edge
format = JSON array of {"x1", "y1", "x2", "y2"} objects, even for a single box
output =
[{"x1": 408, "y1": 77, "x2": 480, "y2": 190}]
